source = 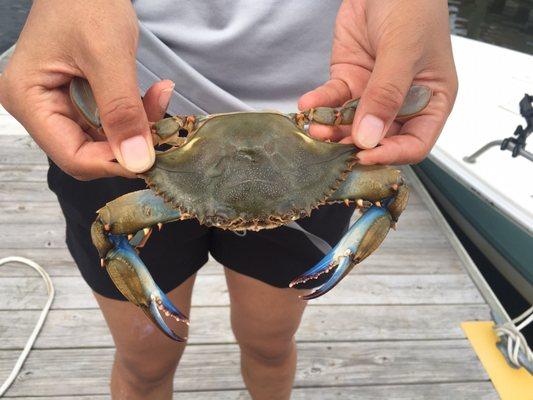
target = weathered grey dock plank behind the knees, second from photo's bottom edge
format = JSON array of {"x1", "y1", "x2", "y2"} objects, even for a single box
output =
[{"x1": 0, "y1": 339, "x2": 488, "y2": 396}]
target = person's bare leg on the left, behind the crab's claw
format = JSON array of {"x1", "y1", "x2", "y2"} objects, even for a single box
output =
[{"x1": 95, "y1": 276, "x2": 195, "y2": 400}]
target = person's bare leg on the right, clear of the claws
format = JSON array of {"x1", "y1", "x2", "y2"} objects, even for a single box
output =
[{"x1": 225, "y1": 269, "x2": 306, "y2": 400}]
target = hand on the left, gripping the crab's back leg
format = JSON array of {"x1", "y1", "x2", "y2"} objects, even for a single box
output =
[{"x1": 0, "y1": 0, "x2": 173, "y2": 180}]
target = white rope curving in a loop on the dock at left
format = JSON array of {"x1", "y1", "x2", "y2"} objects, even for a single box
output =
[{"x1": 0, "y1": 257, "x2": 55, "y2": 397}]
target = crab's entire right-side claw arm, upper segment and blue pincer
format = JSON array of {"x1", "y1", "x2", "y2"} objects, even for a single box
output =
[{"x1": 289, "y1": 167, "x2": 409, "y2": 300}]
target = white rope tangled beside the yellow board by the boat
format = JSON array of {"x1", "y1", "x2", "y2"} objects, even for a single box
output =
[{"x1": 494, "y1": 307, "x2": 533, "y2": 368}]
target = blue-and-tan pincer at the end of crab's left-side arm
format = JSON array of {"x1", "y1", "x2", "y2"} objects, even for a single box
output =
[{"x1": 105, "y1": 235, "x2": 189, "y2": 342}]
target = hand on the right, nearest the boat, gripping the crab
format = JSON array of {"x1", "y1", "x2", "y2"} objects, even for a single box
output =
[{"x1": 298, "y1": 0, "x2": 457, "y2": 165}]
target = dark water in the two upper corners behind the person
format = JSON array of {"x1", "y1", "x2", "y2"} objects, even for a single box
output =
[{"x1": 0, "y1": 0, "x2": 533, "y2": 54}]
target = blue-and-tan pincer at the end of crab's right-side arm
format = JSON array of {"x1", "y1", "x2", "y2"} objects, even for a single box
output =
[{"x1": 289, "y1": 205, "x2": 392, "y2": 300}]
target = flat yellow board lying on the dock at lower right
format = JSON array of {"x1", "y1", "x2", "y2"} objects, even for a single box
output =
[{"x1": 461, "y1": 321, "x2": 533, "y2": 400}]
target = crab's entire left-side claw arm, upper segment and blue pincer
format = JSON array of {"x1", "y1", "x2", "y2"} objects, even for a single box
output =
[{"x1": 91, "y1": 190, "x2": 188, "y2": 342}]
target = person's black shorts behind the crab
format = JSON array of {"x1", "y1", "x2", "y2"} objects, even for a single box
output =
[{"x1": 48, "y1": 162, "x2": 354, "y2": 300}]
